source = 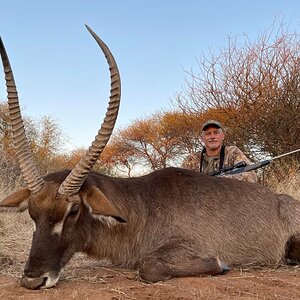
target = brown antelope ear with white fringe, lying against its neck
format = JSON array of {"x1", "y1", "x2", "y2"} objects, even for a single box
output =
[{"x1": 79, "y1": 186, "x2": 126, "y2": 223}]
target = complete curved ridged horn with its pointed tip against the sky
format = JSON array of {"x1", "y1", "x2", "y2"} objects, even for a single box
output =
[{"x1": 58, "y1": 25, "x2": 121, "y2": 195}]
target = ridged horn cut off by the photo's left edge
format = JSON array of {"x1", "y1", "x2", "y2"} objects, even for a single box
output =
[{"x1": 0, "y1": 38, "x2": 44, "y2": 193}]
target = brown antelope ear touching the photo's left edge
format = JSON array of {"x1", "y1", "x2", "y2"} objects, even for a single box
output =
[{"x1": 0, "y1": 188, "x2": 30, "y2": 212}]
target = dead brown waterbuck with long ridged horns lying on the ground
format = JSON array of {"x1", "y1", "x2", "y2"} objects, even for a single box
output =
[{"x1": 0, "y1": 27, "x2": 300, "y2": 289}]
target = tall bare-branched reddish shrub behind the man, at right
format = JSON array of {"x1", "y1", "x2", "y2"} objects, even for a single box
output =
[{"x1": 174, "y1": 19, "x2": 300, "y2": 166}]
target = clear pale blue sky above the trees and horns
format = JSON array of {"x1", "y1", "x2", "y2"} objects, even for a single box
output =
[{"x1": 0, "y1": 0, "x2": 300, "y2": 150}]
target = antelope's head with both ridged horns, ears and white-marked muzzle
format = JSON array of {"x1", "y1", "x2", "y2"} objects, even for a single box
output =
[{"x1": 0, "y1": 26, "x2": 124, "y2": 289}]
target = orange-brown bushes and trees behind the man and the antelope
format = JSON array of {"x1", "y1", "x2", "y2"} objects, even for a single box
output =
[{"x1": 0, "y1": 21, "x2": 300, "y2": 185}]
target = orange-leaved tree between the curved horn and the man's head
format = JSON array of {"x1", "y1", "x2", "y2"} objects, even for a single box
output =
[{"x1": 100, "y1": 111, "x2": 200, "y2": 176}]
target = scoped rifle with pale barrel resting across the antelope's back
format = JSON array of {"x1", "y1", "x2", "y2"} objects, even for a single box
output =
[{"x1": 208, "y1": 149, "x2": 300, "y2": 176}]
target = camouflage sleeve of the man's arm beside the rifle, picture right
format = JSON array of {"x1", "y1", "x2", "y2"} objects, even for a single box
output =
[{"x1": 224, "y1": 146, "x2": 257, "y2": 182}]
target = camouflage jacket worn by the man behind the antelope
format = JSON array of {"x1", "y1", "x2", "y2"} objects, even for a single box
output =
[{"x1": 182, "y1": 146, "x2": 257, "y2": 182}]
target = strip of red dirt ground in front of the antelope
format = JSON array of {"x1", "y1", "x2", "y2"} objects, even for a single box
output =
[{"x1": 0, "y1": 266, "x2": 300, "y2": 300}]
